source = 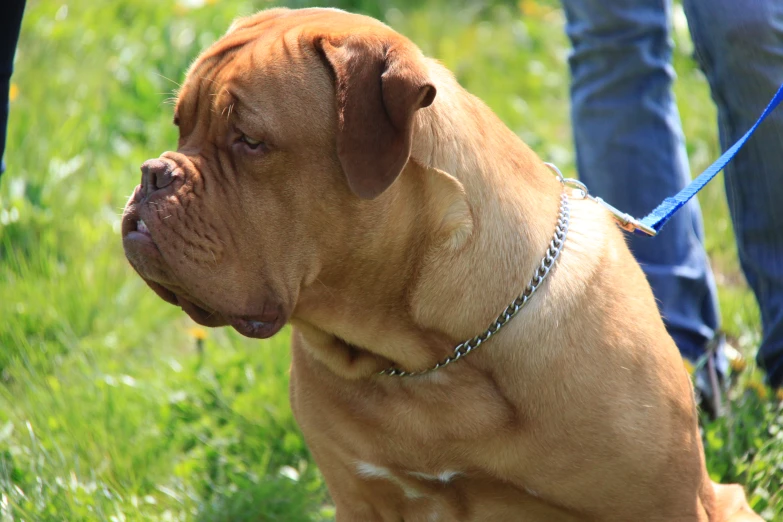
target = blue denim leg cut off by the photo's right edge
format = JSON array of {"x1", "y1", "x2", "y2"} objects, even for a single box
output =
[{"x1": 684, "y1": 0, "x2": 783, "y2": 387}]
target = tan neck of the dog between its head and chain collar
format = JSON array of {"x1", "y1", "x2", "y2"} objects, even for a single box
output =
[{"x1": 292, "y1": 61, "x2": 561, "y2": 378}]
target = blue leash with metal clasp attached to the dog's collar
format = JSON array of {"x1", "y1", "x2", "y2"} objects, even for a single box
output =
[{"x1": 548, "y1": 85, "x2": 783, "y2": 236}]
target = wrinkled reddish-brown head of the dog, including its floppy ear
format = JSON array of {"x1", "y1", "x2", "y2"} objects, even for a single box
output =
[{"x1": 122, "y1": 9, "x2": 435, "y2": 337}]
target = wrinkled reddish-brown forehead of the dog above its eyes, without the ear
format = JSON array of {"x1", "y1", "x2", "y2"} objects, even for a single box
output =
[{"x1": 174, "y1": 8, "x2": 390, "y2": 145}]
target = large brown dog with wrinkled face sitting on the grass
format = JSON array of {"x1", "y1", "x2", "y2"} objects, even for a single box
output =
[{"x1": 123, "y1": 9, "x2": 759, "y2": 522}]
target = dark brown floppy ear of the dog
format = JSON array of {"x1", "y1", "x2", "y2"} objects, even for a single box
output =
[{"x1": 314, "y1": 34, "x2": 435, "y2": 199}]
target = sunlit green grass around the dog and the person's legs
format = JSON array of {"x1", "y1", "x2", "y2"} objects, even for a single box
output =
[{"x1": 0, "y1": 0, "x2": 783, "y2": 522}]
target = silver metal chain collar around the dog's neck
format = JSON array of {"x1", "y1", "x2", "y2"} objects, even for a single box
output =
[{"x1": 378, "y1": 177, "x2": 571, "y2": 377}]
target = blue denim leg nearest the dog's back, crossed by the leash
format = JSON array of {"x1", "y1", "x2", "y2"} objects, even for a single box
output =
[{"x1": 562, "y1": 0, "x2": 719, "y2": 360}]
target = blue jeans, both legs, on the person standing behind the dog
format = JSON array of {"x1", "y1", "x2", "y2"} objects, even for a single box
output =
[{"x1": 562, "y1": 0, "x2": 783, "y2": 386}]
